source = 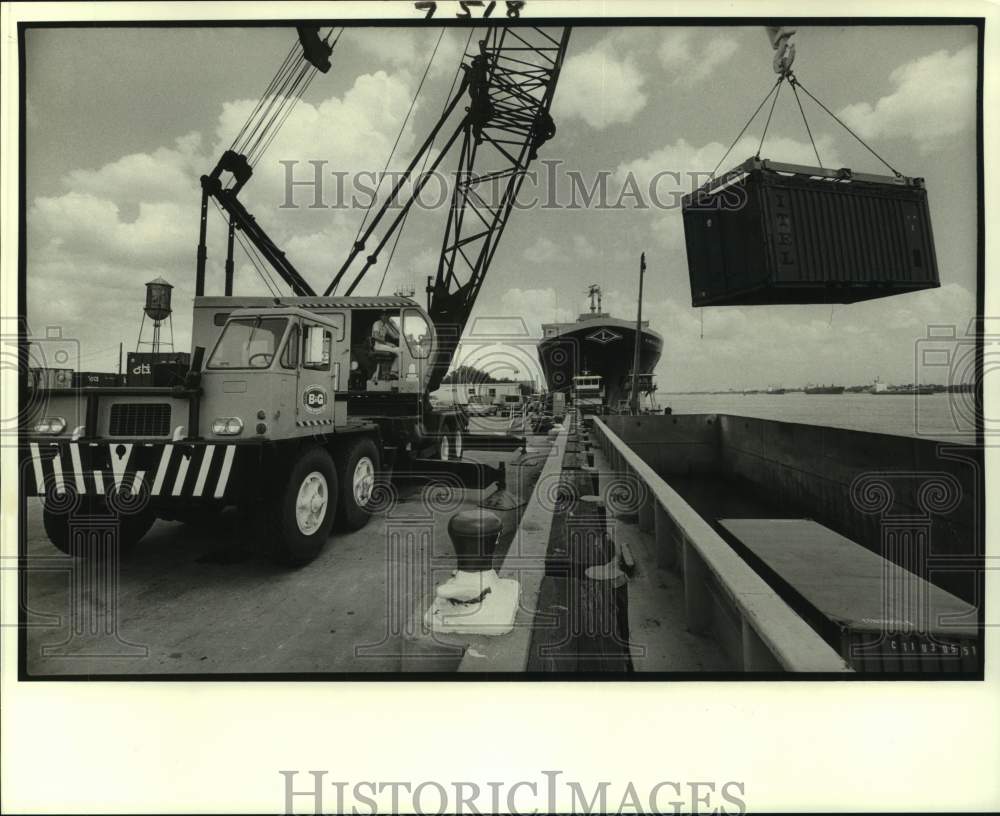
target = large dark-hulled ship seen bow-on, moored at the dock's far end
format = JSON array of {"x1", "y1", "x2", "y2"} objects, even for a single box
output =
[{"x1": 538, "y1": 284, "x2": 663, "y2": 409}]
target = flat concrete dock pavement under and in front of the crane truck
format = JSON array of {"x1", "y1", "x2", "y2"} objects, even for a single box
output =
[{"x1": 24, "y1": 420, "x2": 551, "y2": 677}]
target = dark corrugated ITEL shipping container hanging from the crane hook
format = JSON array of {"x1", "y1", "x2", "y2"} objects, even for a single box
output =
[{"x1": 682, "y1": 158, "x2": 941, "y2": 306}]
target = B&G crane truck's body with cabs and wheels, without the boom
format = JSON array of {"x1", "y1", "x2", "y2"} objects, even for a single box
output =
[{"x1": 23, "y1": 297, "x2": 464, "y2": 564}]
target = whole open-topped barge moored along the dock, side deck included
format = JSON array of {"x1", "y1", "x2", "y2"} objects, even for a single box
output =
[{"x1": 527, "y1": 414, "x2": 984, "y2": 678}]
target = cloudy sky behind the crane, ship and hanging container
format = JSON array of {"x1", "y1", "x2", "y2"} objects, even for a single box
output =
[{"x1": 26, "y1": 19, "x2": 976, "y2": 391}]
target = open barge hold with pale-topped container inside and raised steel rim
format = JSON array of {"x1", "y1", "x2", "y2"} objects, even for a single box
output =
[{"x1": 593, "y1": 414, "x2": 983, "y2": 677}]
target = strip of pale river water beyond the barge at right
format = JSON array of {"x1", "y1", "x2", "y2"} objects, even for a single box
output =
[{"x1": 657, "y1": 392, "x2": 975, "y2": 444}]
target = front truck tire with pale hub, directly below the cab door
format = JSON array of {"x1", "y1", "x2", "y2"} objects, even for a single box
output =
[{"x1": 270, "y1": 448, "x2": 337, "y2": 567}]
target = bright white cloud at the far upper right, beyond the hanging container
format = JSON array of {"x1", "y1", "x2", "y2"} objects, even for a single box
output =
[{"x1": 840, "y1": 45, "x2": 976, "y2": 153}]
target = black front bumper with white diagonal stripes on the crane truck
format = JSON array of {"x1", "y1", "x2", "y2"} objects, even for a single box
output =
[{"x1": 24, "y1": 441, "x2": 246, "y2": 499}]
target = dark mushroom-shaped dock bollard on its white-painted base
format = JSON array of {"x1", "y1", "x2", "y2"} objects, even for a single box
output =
[{"x1": 424, "y1": 509, "x2": 521, "y2": 635}]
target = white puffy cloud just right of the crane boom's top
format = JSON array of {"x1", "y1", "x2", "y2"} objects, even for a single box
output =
[{"x1": 553, "y1": 35, "x2": 647, "y2": 130}]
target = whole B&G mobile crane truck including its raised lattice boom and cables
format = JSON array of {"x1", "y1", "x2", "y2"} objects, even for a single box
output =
[{"x1": 21, "y1": 26, "x2": 569, "y2": 565}]
